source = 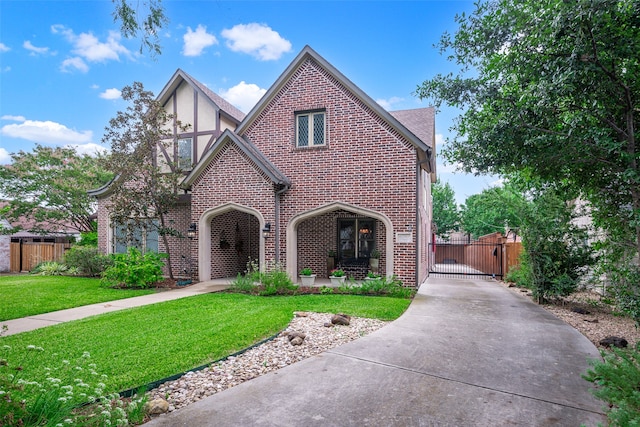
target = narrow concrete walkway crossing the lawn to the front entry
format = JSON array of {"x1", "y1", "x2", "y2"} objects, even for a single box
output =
[{"x1": 0, "y1": 279, "x2": 233, "y2": 336}]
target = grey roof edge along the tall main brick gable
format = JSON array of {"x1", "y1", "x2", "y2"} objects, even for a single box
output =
[{"x1": 236, "y1": 46, "x2": 433, "y2": 167}]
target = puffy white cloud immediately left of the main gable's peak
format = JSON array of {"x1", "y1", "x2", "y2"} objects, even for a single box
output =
[{"x1": 222, "y1": 23, "x2": 291, "y2": 61}]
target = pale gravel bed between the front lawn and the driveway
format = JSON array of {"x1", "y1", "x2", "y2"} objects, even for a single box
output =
[{"x1": 147, "y1": 312, "x2": 389, "y2": 412}]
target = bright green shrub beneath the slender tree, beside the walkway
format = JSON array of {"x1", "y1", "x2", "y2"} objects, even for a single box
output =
[{"x1": 102, "y1": 248, "x2": 165, "y2": 288}]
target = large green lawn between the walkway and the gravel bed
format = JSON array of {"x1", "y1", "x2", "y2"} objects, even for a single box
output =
[{"x1": 0, "y1": 293, "x2": 410, "y2": 391}]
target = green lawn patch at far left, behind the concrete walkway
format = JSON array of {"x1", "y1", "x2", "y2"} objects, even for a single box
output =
[{"x1": 0, "y1": 275, "x2": 155, "y2": 322}]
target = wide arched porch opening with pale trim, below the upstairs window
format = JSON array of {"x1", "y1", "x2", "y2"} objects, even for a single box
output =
[{"x1": 286, "y1": 202, "x2": 394, "y2": 277}]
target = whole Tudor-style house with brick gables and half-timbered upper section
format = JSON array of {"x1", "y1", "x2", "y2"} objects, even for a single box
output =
[{"x1": 92, "y1": 46, "x2": 435, "y2": 286}]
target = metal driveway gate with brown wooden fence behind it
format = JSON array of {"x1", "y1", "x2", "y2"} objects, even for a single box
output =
[{"x1": 429, "y1": 239, "x2": 503, "y2": 279}]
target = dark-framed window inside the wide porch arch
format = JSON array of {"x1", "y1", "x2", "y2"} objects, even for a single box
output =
[{"x1": 338, "y1": 218, "x2": 376, "y2": 260}]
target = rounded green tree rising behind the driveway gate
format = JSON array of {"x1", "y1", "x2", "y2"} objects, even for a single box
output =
[{"x1": 460, "y1": 185, "x2": 526, "y2": 238}]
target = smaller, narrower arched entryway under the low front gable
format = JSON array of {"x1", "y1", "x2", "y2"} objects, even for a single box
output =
[{"x1": 198, "y1": 202, "x2": 265, "y2": 281}]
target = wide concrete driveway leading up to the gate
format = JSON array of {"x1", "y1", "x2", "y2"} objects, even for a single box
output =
[{"x1": 147, "y1": 278, "x2": 605, "y2": 427}]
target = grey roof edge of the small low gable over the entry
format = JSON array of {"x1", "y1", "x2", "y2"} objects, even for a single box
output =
[{"x1": 182, "y1": 129, "x2": 291, "y2": 188}]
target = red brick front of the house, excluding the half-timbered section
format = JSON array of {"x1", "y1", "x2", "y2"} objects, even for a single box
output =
[{"x1": 92, "y1": 48, "x2": 434, "y2": 286}]
